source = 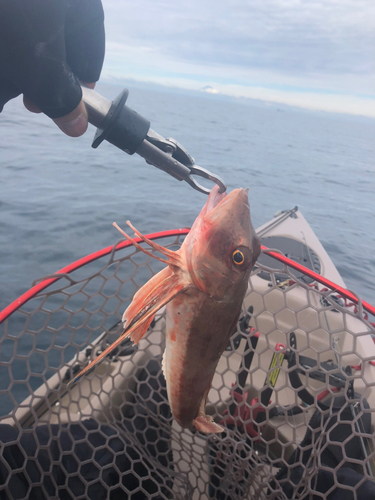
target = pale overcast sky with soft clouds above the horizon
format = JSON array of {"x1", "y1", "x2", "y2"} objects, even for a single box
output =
[{"x1": 103, "y1": 0, "x2": 375, "y2": 117}]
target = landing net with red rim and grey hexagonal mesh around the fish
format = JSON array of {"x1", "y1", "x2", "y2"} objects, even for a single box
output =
[{"x1": 0, "y1": 230, "x2": 375, "y2": 500}]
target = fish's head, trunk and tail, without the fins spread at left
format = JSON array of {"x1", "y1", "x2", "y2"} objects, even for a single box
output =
[{"x1": 164, "y1": 189, "x2": 260, "y2": 432}]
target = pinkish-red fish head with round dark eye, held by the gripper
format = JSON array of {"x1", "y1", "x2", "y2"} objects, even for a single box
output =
[{"x1": 183, "y1": 186, "x2": 260, "y2": 301}]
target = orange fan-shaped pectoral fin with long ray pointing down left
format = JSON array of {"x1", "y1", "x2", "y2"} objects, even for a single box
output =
[{"x1": 68, "y1": 267, "x2": 189, "y2": 387}]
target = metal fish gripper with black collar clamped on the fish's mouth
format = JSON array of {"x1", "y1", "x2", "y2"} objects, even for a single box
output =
[{"x1": 82, "y1": 86, "x2": 226, "y2": 194}]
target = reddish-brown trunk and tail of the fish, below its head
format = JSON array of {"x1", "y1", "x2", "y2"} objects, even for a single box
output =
[{"x1": 163, "y1": 291, "x2": 241, "y2": 432}]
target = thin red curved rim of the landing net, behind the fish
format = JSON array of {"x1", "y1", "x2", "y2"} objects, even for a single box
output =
[{"x1": 0, "y1": 228, "x2": 375, "y2": 324}]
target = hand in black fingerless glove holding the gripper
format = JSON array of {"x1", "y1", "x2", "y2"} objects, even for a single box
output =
[{"x1": 0, "y1": 0, "x2": 104, "y2": 137}]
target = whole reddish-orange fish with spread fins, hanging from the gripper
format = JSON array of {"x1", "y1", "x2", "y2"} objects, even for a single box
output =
[{"x1": 69, "y1": 186, "x2": 260, "y2": 434}]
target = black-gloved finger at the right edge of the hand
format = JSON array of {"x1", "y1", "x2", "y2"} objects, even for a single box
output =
[{"x1": 65, "y1": 0, "x2": 105, "y2": 82}]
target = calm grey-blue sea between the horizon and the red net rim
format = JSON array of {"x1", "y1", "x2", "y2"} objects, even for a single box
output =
[{"x1": 0, "y1": 82, "x2": 375, "y2": 310}]
